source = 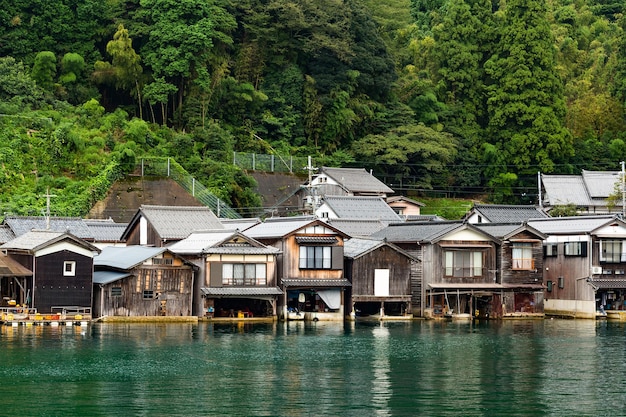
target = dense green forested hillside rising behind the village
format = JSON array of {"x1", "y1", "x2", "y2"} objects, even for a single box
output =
[{"x1": 0, "y1": 0, "x2": 626, "y2": 216}]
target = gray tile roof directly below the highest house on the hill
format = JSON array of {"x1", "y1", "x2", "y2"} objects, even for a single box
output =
[{"x1": 316, "y1": 195, "x2": 401, "y2": 222}]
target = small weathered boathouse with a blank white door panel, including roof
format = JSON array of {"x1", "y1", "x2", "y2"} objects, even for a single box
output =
[{"x1": 344, "y1": 238, "x2": 419, "y2": 319}]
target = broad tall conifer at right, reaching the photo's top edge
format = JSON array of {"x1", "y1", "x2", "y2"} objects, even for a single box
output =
[{"x1": 485, "y1": 0, "x2": 573, "y2": 174}]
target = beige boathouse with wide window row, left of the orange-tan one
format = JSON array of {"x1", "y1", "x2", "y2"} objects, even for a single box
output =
[{"x1": 169, "y1": 230, "x2": 283, "y2": 318}]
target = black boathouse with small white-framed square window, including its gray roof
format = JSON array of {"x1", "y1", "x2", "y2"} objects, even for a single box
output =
[{"x1": 0, "y1": 231, "x2": 100, "y2": 313}]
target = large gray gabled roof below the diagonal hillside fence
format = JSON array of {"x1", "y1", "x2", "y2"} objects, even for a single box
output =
[{"x1": 122, "y1": 205, "x2": 224, "y2": 240}]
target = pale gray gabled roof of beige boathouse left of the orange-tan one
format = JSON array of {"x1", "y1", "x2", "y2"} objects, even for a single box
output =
[{"x1": 167, "y1": 230, "x2": 279, "y2": 255}]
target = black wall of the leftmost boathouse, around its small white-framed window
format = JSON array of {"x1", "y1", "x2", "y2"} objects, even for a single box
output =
[{"x1": 33, "y1": 250, "x2": 93, "y2": 313}]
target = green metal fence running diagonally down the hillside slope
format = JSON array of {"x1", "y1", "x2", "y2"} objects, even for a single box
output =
[{"x1": 138, "y1": 158, "x2": 241, "y2": 219}]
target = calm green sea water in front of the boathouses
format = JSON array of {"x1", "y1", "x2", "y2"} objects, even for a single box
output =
[{"x1": 0, "y1": 320, "x2": 626, "y2": 416}]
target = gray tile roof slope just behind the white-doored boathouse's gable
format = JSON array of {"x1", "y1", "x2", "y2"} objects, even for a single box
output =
[{"x1": 371, "y1": 221, "x2": 463, "y2": 243}]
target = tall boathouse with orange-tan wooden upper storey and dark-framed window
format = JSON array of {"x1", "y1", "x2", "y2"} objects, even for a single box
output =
[{"x1": 244, "y1": 216, "x2": 351, "y2": 321}]
